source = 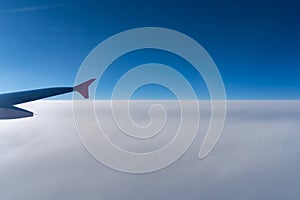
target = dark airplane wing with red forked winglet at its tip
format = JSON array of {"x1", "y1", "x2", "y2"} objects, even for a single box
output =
[{"x1": 0, "y1": 79, "x2": 96, "y2": 119}]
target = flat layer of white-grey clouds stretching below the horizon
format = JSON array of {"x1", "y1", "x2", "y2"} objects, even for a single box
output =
[{"x1": 0, "y1": 101, "x2": 300, "y2": 200}]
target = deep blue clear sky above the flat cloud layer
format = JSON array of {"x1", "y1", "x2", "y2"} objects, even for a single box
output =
[{"x1": 0, "y1": 0, "x2": 300, "y2": 99}]
